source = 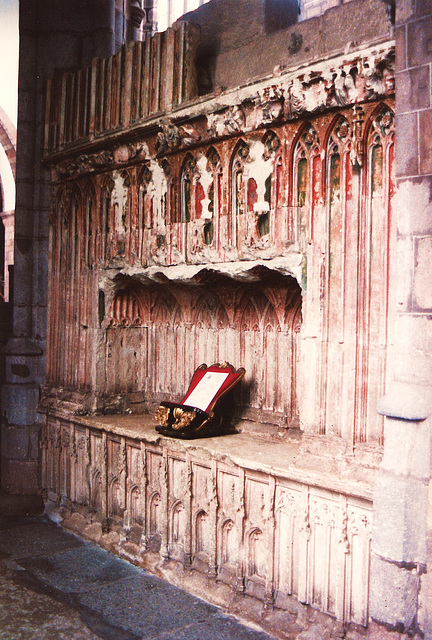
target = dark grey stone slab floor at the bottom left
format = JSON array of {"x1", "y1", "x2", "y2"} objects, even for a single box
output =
[{"x1": 0, "y1": 516, "x2": 271, "y2": 640}]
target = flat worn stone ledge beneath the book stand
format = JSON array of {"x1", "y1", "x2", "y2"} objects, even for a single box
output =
[{"x1": 49, "y1": 412, "x2": 376, "y2": 500}]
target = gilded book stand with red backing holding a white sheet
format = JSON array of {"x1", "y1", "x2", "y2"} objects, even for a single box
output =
[{"x1": 155, "y1": 362, "x2": 245, "y2": 439}]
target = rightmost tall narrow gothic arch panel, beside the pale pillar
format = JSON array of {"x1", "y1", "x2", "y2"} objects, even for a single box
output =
[{"x1": 353, "y1": 104, "x2": 395, "y2": 442}]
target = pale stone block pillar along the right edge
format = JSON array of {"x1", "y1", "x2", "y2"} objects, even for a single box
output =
[{"x1": 369, "y1": 0, "x2": 432, "y2": 638}]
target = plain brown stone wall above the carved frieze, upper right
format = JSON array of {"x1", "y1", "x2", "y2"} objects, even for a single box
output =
[{"x1": 182, "y1": 0, "x2": 393, "y2": 94}]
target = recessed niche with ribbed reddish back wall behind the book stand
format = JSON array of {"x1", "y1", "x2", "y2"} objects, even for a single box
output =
[{"x1": 104, "y1": 267, "x2": 301, "y2": 428}]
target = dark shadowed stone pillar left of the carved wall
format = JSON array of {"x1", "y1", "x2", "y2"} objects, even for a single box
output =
[{"x1": 1, "y1": 0, "x2": 118, "y2": 495}]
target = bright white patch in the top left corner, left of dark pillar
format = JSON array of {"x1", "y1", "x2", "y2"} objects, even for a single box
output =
[{"x1": 0, "y1": 0, "x2": 19, "y2": 126}]
